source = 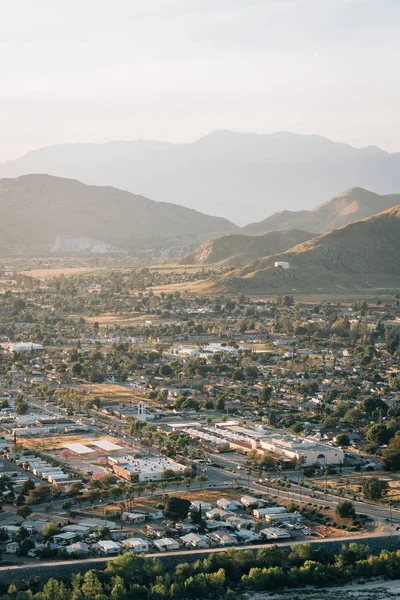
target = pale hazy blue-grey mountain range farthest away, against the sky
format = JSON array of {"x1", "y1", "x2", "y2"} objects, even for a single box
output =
[{"x1": 0, "y1": 131, "x2": 400, "y2": 224}]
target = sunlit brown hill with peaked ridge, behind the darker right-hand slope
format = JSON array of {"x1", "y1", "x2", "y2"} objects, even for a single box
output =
[{"x1": 242, "y1": 188, "x2": 400, "y2": 235}]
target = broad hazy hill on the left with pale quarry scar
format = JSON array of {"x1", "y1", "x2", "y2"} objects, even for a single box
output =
[{"x1": 0, "y1": 175, "x2": 237, "y2": 256}]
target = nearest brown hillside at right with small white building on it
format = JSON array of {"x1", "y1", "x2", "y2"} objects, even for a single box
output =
[{"x1": 214, "y1": 204, "x2": 400, "y2": 294}]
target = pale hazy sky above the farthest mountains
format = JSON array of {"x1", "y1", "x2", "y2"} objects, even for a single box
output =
[{"x1": 0, "y1": 0, "x2": 400, "y2": 160}]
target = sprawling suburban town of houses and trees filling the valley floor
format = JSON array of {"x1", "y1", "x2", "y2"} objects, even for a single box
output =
[{"x1": 0, "y1": 267, "x2": 400, "y2": 584}]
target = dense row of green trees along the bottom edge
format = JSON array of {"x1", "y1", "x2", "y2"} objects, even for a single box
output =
[{"x1": 0, "y1": 543, "x2": 400, "y2": 600}]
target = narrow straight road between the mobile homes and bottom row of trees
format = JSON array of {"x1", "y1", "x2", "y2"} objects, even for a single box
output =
[{"x1": 0, "y1": 532, "x2": 400, "y2": 573}]
